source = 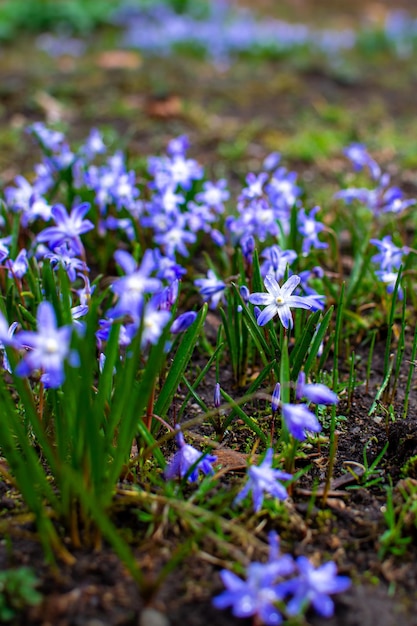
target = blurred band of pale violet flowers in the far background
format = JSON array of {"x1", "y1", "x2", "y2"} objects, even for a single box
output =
[{"x1": 114, "y1": 0, "x2": 417, "y2": 66}]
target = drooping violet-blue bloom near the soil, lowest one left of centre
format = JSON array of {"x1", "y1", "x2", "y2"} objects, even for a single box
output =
[{"x1": 164, "y1": 426, "x2": 217, "y2": 482}]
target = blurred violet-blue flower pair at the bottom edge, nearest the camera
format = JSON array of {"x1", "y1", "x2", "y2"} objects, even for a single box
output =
[{"x1": 213, "y1": 532, "x2": 351, "y2": 626}]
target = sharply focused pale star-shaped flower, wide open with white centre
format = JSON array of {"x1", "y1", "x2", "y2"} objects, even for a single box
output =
[{"x1": 249, "y1": 274, "x2": 313, "y2": 328}]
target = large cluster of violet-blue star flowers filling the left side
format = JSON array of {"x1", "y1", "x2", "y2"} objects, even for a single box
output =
[{"x1": 0, "y1": 123, "x2": 206, "y2": 387}]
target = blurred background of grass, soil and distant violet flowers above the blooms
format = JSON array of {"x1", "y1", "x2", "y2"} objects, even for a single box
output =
[{"x1": 0, "y1": 0, "x2": 417, "y2": 196}]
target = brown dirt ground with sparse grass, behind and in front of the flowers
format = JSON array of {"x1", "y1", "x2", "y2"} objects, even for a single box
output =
[{"x1": 0, "y1": 0, "x2": 417, "y2": 626}]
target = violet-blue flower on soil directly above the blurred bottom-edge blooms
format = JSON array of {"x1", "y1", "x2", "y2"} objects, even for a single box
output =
[{"x1": 234, "y1": 448, "x2": 292, "y2": 513}]
